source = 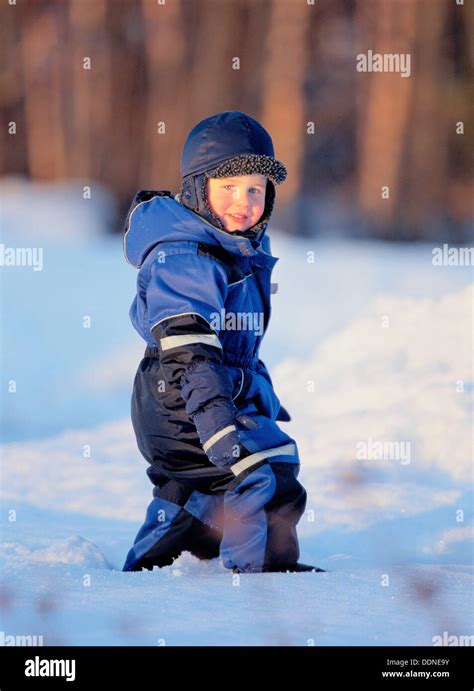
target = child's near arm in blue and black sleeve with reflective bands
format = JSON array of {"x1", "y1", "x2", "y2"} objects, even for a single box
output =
[{"x1": 146, "y1": 253, "x2": 251, "y2": 466}]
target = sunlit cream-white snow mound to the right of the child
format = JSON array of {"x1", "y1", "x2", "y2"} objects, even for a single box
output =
[{"x1": 273, "y1": 285, "x2": 474, "y2": 494}]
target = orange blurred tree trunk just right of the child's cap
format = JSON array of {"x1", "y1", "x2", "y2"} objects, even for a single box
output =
[{"x1": 262, "y1": 0, "x2": 314, "y2": 209}]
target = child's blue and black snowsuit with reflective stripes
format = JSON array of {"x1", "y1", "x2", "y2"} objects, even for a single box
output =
[{"x1": 123, "y1": 190, "x2": 306, "y2": 572}]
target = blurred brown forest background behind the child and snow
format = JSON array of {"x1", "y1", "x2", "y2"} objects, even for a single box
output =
[{"x1": 0, "y1": 0, "x2": 474, "y2": 243}]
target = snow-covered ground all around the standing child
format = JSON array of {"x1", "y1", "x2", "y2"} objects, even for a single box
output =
[{"x1": 0, "y1": 180, "x2": 474, "y2": 645}]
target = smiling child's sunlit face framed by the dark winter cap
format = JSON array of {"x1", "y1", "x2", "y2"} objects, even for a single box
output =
[{"x1": 207, "y1": 175, "x2": 267, "y2": 231}]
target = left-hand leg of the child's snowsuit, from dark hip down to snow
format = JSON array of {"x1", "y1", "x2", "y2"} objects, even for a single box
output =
[{"x1": 123, "y1": 350, "x2": 223, "y2": 571}]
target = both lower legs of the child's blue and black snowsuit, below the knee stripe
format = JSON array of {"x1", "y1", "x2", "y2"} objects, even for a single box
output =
[{"x1": 123, "y1": 461, "x2": 306, "y2": 571}]
